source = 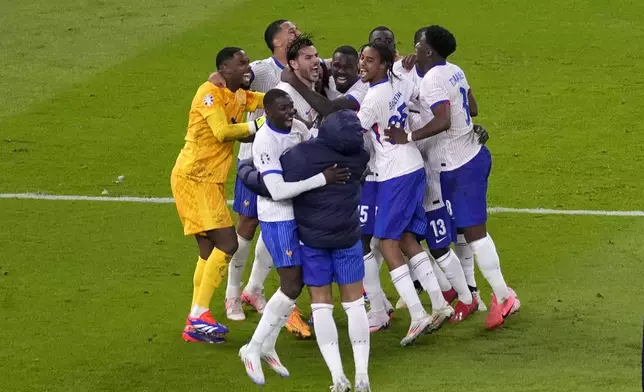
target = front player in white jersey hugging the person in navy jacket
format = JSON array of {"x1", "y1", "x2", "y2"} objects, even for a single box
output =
[{"x1": 239, "y1": 89, "x2": 350, "y2": 385}]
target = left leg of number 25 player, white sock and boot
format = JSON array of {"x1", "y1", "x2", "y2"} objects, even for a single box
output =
[{"x1": 380, "y1": 238, "x2": 430, "y2": 346}]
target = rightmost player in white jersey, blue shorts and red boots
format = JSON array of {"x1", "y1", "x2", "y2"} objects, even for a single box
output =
[{"x1": 386, "y1": 26, "x2": 520, "y2": 328}]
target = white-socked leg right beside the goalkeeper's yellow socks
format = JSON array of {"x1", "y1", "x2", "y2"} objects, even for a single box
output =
[{"x1": 226, "y1": 214, "x2": 259, "y2": 320}]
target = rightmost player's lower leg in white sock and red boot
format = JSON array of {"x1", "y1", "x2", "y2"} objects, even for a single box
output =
[{"x1": 464, "y1": 223, "x2": 521, "y2": 328}]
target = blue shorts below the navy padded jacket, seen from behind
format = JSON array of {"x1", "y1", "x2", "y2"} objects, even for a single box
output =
[{"x1": 301, "y1": 241, "x2": 364, "y2": 287}]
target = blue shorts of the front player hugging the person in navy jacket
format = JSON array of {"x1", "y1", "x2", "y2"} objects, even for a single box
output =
[{"x1": 259, "y1": 220, "x2": 302, "y2": 268}]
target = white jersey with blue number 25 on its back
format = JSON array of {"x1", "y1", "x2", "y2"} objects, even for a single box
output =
[{"x1": 358, "y1": 77, "x2": 423, "y2": 182}]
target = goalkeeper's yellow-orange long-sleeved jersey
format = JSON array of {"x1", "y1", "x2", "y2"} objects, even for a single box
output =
[{"x1": 173, "y1": 81, "x2": 264, "y2": 183}]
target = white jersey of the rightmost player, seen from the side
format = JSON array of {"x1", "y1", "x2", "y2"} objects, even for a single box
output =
[{"x1": 420, "y1": 63, "x2": 481, "y2": 171}]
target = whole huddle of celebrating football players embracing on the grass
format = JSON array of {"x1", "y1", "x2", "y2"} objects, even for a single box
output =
[{"x1": 172, "y1": 20, "x2": 520, "y2": 392}]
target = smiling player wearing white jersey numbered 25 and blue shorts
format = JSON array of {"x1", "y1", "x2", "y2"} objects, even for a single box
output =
[{"x1": 358, "y1": 43, "x2": 453, "y2": 345}]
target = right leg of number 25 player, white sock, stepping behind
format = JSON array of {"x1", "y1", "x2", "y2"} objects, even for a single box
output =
[{"x1": 400, "y1": 233, "x2": 454, "y2": 331}]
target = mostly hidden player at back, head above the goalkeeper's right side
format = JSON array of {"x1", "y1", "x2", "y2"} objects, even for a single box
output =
[{"x1": 225, "y1": 19, "x2": 300, "y2": 320}]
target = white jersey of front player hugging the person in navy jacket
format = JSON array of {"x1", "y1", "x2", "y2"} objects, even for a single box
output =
[{"x1": 252, "y1": 119, "x2": 310, "y2": 222}]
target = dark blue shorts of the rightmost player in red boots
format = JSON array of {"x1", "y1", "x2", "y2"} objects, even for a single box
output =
[{"x1": 441, "y1": 146, "x2": 492, "y2": 228}]
